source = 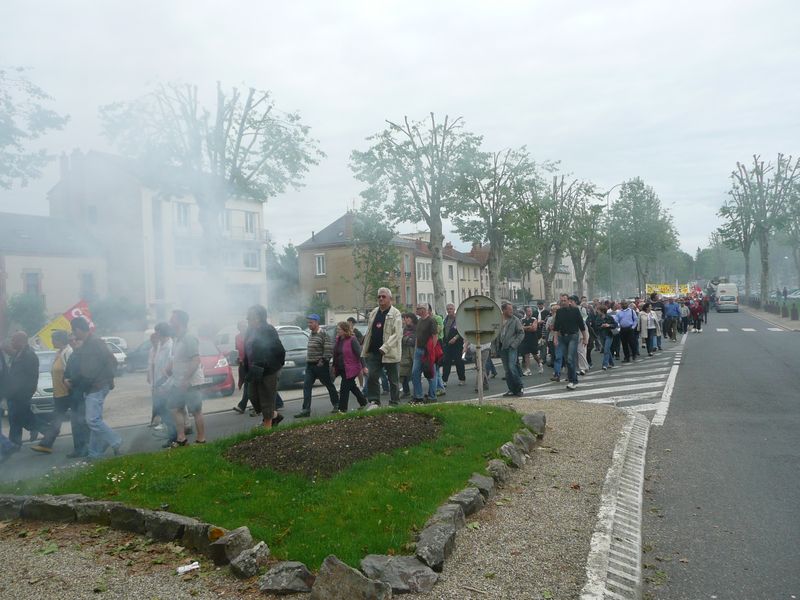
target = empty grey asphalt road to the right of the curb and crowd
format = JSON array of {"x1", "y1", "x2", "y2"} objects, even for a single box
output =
[{"x1": 642, "y1": 313, "x2": 800, "y2": 600}]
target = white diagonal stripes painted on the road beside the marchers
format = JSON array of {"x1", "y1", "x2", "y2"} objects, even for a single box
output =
[{"x1": 525, "y1": 345, "x2": 683, "y2": 417}]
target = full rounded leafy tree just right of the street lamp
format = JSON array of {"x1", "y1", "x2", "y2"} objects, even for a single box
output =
[{"x1": 610, "y1": 177, "x2": 678, "y2": 293}]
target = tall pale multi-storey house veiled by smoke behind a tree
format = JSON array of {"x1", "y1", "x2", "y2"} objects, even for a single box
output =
[{"x1": 48, "y1": 150, "x2": 266, "y2": 324}]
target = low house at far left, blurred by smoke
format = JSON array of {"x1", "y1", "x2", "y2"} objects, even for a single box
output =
[{"x1": 0, "y1": 213, "x2": 108, "y2": 334}]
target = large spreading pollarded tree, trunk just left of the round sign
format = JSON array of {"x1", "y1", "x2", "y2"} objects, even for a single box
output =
[{"x1": 350, "y1": 113, "x2": 481, "y2": 313}]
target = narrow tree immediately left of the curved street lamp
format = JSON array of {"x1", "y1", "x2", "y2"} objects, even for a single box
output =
[{"x1": 567, "y1": 183, "x2": 605, "y2": 296}]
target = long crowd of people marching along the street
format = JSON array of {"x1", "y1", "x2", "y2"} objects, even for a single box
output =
[{"x1": 0, "y1": 288, "x2": 709, "y2": 460}]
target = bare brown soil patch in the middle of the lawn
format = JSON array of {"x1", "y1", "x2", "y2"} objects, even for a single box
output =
[{"x1": 225, "y1": 413, "x2": 442, "y2": 478}]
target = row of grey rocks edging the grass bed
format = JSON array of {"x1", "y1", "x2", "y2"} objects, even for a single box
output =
[{"x1": 0, "y1": 411, "x2": 547, "y2": 600}]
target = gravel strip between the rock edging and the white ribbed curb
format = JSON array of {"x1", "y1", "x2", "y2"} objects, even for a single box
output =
[{"x1": 404, "y1": 399, "x2": 626, "y2": 600}]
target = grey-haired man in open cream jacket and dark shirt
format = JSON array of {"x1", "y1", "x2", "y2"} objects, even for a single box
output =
[{"x1": 361, "y1": 288, "x2": 403, "y2": 406}]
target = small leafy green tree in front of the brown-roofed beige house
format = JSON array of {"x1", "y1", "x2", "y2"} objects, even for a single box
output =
[{"x1": 353, "y1": 205, "x2": 400, "y2": 309}]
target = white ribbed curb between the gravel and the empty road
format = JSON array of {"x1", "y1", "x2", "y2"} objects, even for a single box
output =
[{"x1": 580, "y1": 411, "x2": 650, "y2": 600}]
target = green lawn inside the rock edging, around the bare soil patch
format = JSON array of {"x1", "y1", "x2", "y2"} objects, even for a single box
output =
[{"x1": 4, "y1": 404, "x2": 520, "y2": 569}]
